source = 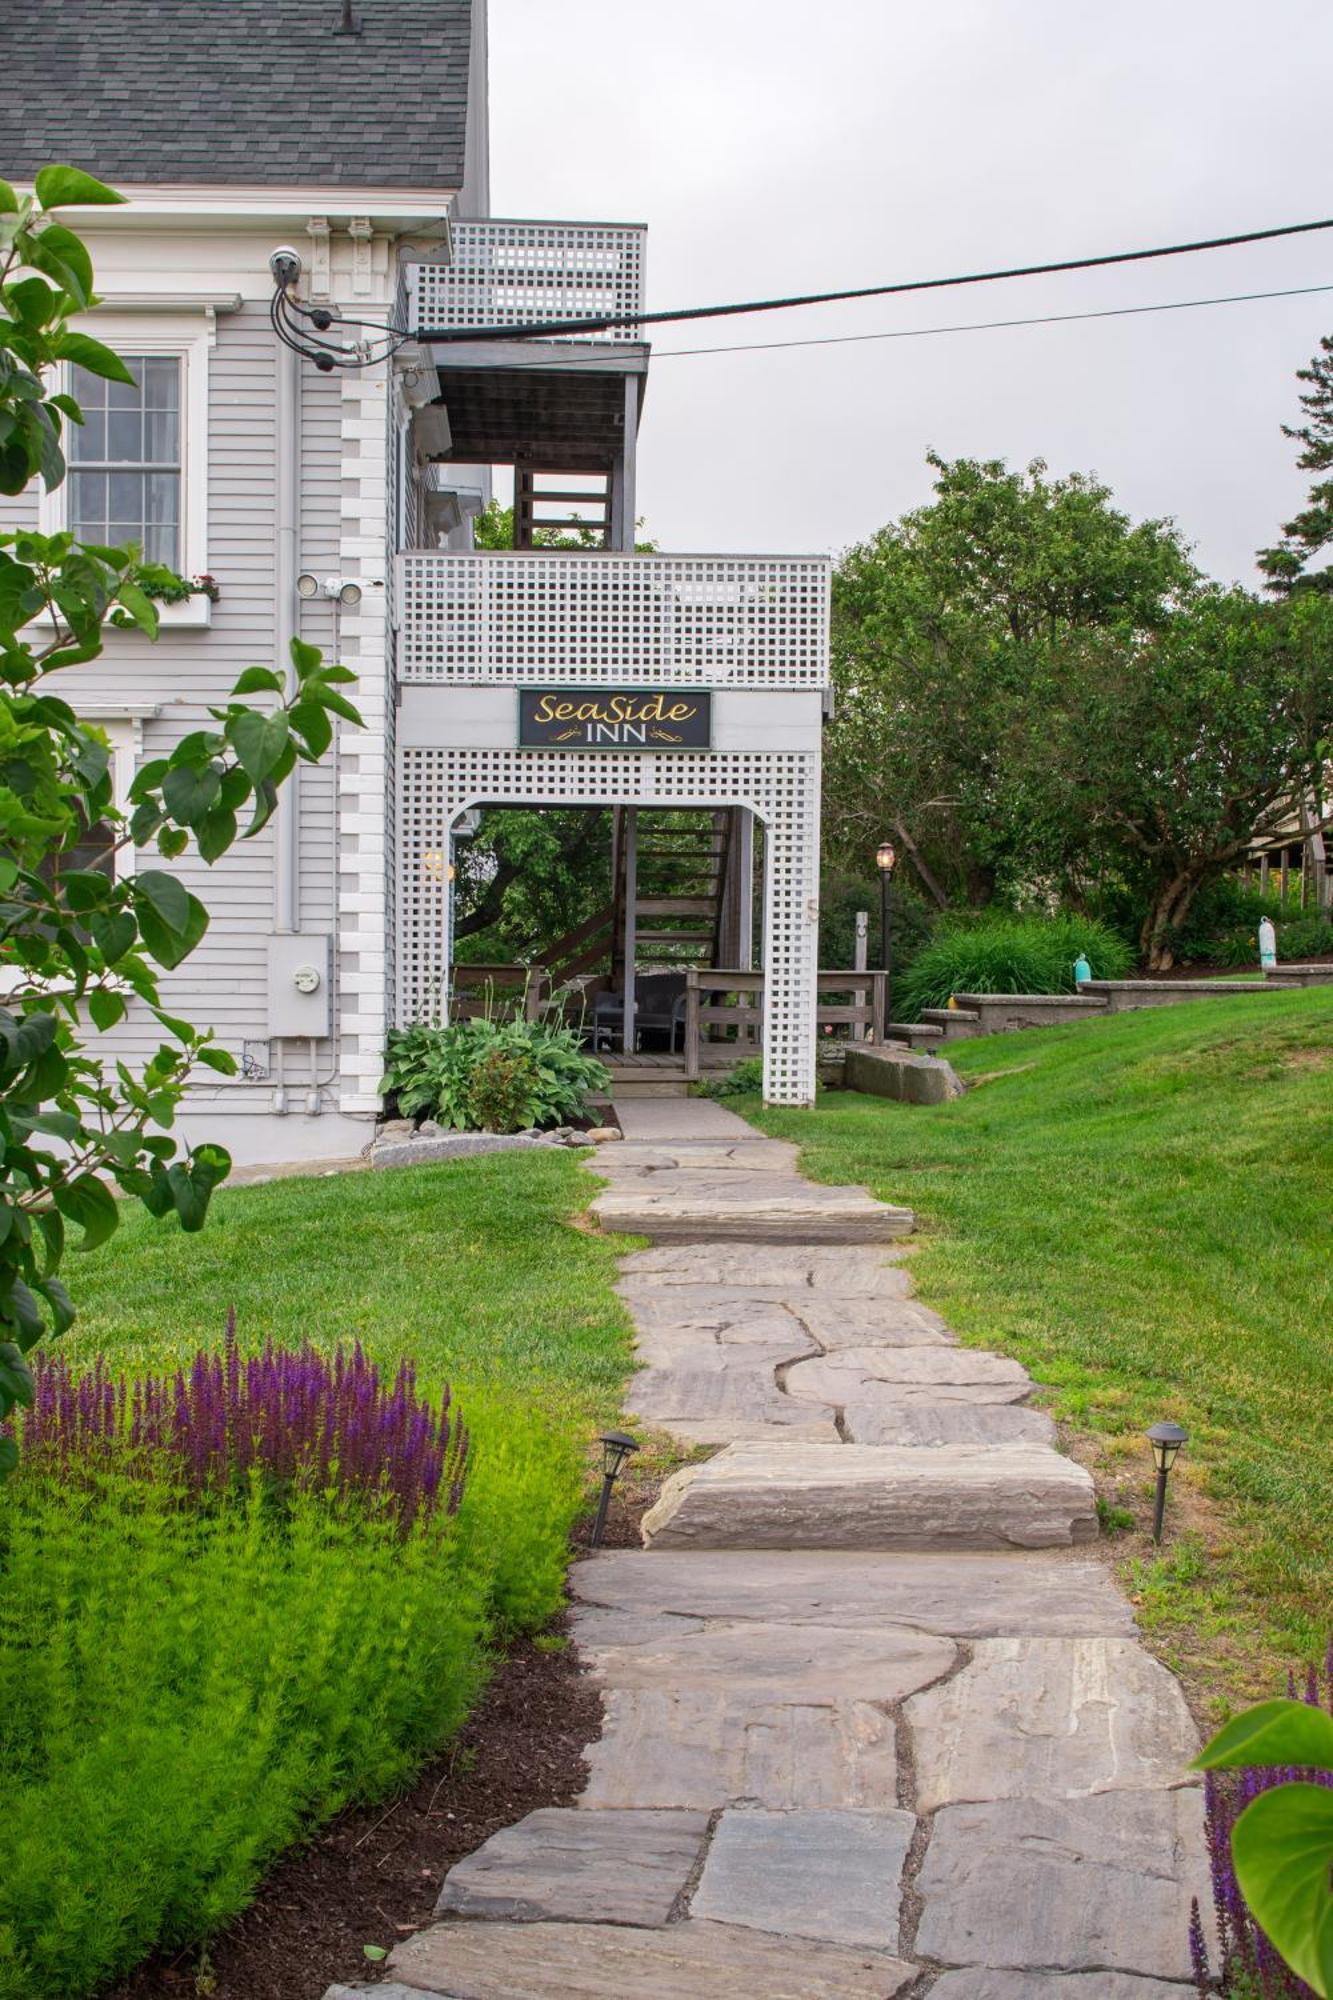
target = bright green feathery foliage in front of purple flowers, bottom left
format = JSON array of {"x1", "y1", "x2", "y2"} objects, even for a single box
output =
[{"x1": 0, "y1": 1472, "x2": 488, "y2": 2000}]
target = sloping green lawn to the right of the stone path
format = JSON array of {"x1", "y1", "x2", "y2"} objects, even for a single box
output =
[{"x1": 747, "y1": 988, "x2": 1333, "y2": 1692}]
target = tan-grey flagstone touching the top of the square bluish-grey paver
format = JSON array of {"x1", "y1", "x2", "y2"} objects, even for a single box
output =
[{"x1": 578, "y1": 1688, "x2": 897, "y2": 1812}]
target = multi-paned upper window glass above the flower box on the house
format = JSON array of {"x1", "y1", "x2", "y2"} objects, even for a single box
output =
[{"x1": 68, "y1": 354, "x2": 182, "y2": 570}]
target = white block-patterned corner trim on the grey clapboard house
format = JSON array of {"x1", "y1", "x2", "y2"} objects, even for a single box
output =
[{"x1": 338, "y1": 368, "x2": 394, "y2": 1112}]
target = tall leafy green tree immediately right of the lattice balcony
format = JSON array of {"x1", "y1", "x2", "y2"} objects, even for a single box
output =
[{"x1": 825, "y1": 454, "x2": 1197, "y2": 904}]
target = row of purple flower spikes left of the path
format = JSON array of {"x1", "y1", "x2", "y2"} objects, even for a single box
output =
[{"x1": 22, "y1": 1316, "x2": 468, "y2": 1532}]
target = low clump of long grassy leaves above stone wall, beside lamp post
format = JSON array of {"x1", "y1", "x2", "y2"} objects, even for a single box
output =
[{"x1": 893, "y1": 914, "x2": 1133, "y2": 1020}]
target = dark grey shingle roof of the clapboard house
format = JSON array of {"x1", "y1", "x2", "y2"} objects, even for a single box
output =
[{"x1": 0, "y1": 0, "x2": 472, "y2": 188}]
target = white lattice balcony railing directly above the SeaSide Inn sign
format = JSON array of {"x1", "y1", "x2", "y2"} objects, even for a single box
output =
[{"x1": 398, "y1": 552, "x2": 831, "y2": 688}]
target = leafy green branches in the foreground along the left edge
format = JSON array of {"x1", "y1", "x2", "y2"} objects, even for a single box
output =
[{"x1": 0, "y1": 166, "x2": 358, "y2": 1472}]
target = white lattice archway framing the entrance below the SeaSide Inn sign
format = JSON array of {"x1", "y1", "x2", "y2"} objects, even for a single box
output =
[{"x1": 396, "y1": 748, "x2": 819, "y2": 1104}]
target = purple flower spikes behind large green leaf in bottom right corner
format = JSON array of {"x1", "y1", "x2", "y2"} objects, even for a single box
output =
[{"x1": 1189, "y1": 1642, "x2": 1333, "y2": 2000}]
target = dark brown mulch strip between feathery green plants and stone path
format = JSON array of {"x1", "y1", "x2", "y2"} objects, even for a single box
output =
[{"x1": 108, "y1": 1478, "x2": 658, "y2": 2000}]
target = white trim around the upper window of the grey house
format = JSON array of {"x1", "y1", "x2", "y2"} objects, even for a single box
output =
[{"x1": 38, "y1": 306, "x2": 216, "y2": 640}]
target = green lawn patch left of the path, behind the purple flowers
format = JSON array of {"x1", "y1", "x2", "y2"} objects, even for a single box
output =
[{"x1": 64, "y1": 1150, "x2": 630, "y2": 1434}]
